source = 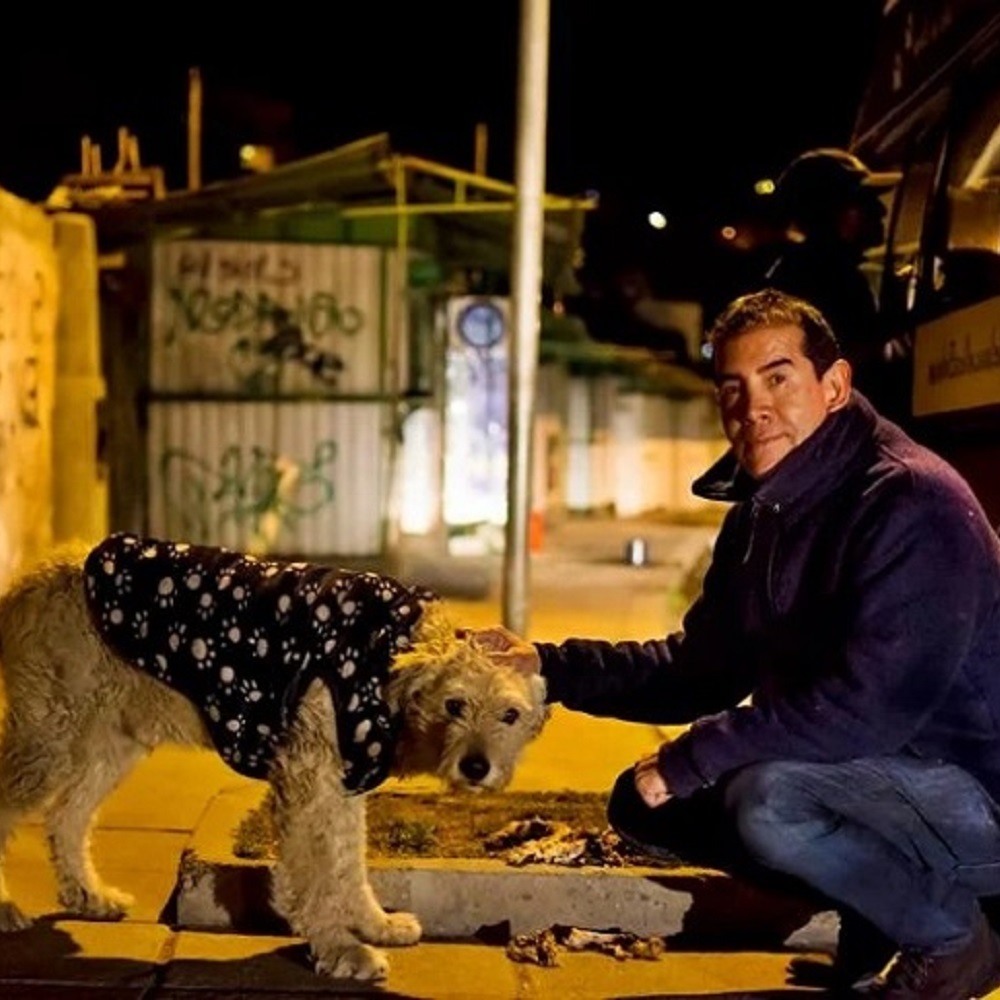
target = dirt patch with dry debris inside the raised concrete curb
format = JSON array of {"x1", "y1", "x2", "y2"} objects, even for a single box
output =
[{"x1": 233, "y1": 792, "x2": 676, "y2": 866}]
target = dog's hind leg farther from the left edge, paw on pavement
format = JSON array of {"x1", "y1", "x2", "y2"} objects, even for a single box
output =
[{"x1": 45, "y1": 727, "x2": 146, "y2": 920}]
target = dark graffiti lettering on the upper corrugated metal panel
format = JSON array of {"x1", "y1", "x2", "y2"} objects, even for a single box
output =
[{"x1": 158, "y1": 242, "x2": 366, "y2": 395}]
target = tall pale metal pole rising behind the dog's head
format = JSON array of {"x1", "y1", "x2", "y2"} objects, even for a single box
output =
[{"x1": 502, "y1": 0, "x2": 549, "y2": 635}]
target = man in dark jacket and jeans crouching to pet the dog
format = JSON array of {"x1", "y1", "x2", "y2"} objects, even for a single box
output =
[{"x1": 478, "y1": 289, "x2": 1000, "y2": 1000}]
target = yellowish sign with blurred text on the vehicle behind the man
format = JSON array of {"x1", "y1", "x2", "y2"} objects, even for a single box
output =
[{"x1": 913, "y1": 297, "x2": 1000, "y2": 417}]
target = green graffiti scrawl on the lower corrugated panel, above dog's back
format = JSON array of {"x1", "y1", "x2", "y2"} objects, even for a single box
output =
[{"x1": 159, "y1": 440, "x2": 337, "y2": 549}]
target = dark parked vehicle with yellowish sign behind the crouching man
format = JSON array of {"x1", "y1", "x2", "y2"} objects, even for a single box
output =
[{"x1": 851, "y1": 0, "x2": 1000, "y2": 526}]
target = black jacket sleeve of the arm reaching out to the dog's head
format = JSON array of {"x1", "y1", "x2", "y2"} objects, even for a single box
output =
[{"x1": 536, "y1": 518, "x2": 752, "y2": 724}]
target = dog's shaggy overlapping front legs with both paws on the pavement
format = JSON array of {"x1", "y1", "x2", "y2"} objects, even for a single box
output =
[{"x1": 271, "y1": 686, "x2": 420, "y2": 979}]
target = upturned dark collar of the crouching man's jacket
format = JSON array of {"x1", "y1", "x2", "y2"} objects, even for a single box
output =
[{"x1": 692, "y1": 391, "x2": 880, "y2": 510}]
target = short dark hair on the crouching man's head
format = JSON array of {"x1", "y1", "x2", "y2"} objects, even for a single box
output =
[{"x1": 708, "y1": 288, "x2": 843, "y2": 377}]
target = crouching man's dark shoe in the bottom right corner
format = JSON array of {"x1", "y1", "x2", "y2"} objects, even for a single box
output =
[{"x1": 874, "y1": 914, "x2": 1000, "y2": 1000}]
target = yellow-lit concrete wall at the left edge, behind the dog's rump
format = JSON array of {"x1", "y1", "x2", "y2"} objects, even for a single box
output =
[{"x1": 0, "y1": 190, "x2": 106, "y2": 589}]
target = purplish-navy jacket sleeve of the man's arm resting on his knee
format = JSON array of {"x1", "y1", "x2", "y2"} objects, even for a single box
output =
[{"x1": 659, "y1": 484, "x2": 998, "y2": 796}]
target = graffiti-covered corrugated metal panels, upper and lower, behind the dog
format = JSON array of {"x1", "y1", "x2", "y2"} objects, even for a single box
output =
[{"x1": 148, "y1": 240, "x2": 408, "y2": 556}]
